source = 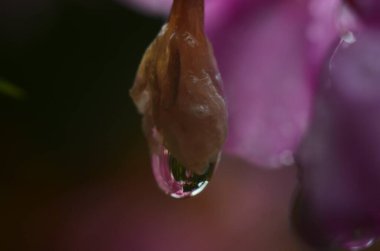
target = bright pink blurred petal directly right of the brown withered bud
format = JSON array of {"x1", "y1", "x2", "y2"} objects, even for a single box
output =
[{"x1": 211, "y1": 1, "x2": 337, "y2": 167}]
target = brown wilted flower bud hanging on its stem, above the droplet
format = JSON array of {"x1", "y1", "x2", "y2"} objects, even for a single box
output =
[{"x1": 130, "y1": 0, "x2": 227, "y2": 174}]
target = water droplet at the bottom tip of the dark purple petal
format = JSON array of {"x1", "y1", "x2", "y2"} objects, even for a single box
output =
[{"x1": 341, "y1": 230, "x2": 375, "y2": 251}]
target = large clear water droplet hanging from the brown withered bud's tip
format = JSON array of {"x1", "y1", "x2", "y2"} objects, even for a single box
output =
[{"x1": 152, "y1": 146, "x2": 217, "y2": 199}]
